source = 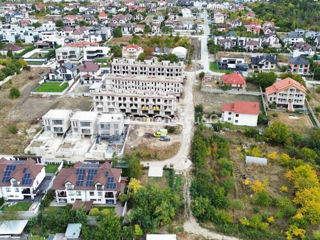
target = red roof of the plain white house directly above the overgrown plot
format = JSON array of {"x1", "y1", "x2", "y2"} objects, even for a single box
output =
[{"x1": 222, "y1": 101, "x2": 260, "y2": 115}]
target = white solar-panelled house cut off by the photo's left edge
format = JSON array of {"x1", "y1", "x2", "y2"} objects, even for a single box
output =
[{"x1": 0, "y1": 158, "x2": 46, "y2": 200}]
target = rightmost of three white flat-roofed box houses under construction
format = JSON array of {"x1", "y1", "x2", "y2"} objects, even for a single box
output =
[{"x1": 98, "y1": 113, "x2": 124, "y2": 139}]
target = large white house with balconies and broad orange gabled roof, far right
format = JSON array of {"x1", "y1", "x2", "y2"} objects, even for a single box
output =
[{"x1": 266, "y1": 77, "x2": 307, "y2": 111}]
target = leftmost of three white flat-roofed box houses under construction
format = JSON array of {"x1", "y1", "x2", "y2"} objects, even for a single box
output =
[{"x1": 42, "y1": 109, "x2": 72, "y2": 136}]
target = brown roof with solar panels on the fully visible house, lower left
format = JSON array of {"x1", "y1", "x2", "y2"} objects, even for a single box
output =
[{"x1": 52, "y1": 162, "x2": 122, "y2": 191}]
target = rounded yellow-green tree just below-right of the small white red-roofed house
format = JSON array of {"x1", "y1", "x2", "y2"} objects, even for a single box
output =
[{"x1": 263, "y1": 122, "x2": 290, "y2": 144}]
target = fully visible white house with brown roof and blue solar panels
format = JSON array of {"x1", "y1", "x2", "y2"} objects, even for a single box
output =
[{"x1": 52, "y1": 162, "x2": 126, "y2": 205}]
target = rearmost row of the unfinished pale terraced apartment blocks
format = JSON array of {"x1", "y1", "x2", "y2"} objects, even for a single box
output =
[{"x1": 111, "y1": 58, "x2": 184, "y2": 77}]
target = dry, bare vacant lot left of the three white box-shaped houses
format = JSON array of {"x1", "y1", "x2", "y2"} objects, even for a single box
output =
[{"x1": 0, "y1": 68, "x2": 91, "y2": 154}]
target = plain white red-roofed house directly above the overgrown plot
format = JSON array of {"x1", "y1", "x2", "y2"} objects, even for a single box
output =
[{"x1": 221, "y1": 101, "x2": 260, "y2": 127}]
